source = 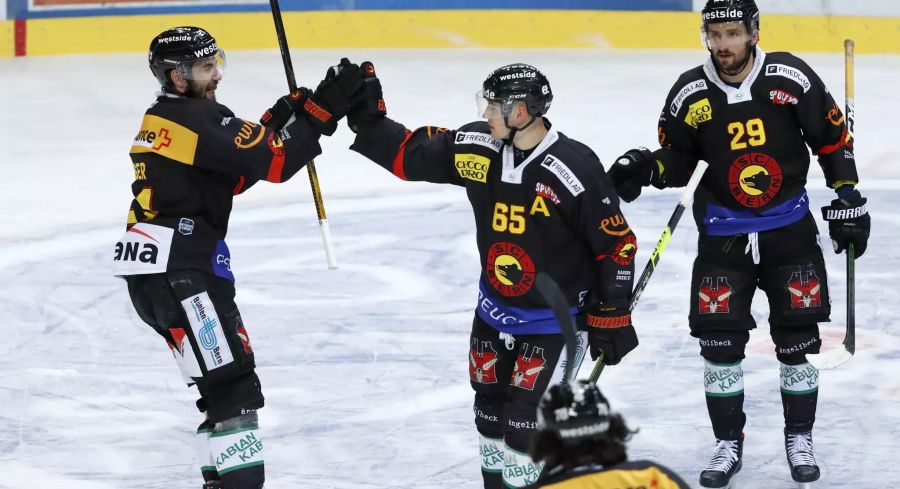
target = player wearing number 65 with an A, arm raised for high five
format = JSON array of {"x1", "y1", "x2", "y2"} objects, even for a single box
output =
[{"x1": 347, "y1": 63, "x2": 638, "y2": 488}]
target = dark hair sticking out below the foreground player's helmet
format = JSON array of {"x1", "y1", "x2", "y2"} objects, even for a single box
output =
[{"x1": 529, "y1": 413, "x2": 638, "y2": 473}]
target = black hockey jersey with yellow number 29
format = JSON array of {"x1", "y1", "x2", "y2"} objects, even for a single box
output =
[{"x1": 653, "y1": 47, "x2": 858, "y2": 236}]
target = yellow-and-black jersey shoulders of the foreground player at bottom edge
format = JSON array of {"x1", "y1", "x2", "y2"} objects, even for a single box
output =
[{"x1": 528, "y1": 460, "x2": 690, "y2": 489}]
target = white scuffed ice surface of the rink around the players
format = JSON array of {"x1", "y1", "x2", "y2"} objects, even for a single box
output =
[{"x1": 0, "y1": 46, "x2": 900, "y2": 489}]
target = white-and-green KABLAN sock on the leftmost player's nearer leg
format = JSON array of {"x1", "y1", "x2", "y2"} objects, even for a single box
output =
[{"x1": 209, "y1": 411, "x2": 266, "y2": 489}]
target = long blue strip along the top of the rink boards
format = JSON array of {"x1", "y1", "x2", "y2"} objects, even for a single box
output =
[{"x1": 0, "y1": 0, "x2": 691, "y2": 19}]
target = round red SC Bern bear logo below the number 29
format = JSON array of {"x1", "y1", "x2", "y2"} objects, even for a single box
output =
[{"x1": 728, "y1": 153, "x2": 782, "y2": 209}]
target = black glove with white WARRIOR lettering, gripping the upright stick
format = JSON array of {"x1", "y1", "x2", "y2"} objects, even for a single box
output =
[{"x1": 822, "y1": 190, "x2": 871, "y2": 258}]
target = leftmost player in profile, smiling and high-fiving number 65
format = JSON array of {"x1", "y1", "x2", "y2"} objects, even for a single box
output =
[{"x1": 115, "y1": 27, "x2": 362, "y2": 489}]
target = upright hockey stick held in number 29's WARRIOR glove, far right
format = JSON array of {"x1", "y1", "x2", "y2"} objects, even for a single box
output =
[{"x1": 806, "y1": 39, "x2": 856, "y2": 370}]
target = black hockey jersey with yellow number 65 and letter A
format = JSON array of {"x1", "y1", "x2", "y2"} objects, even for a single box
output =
[{"x1": 351, "y1": 119, "x2": 637, "y2": 334}]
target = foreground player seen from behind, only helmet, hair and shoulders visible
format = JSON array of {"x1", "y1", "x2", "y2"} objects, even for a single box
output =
[{"x1": 530, "y1": 380, "x2": 690, "y2": 489}]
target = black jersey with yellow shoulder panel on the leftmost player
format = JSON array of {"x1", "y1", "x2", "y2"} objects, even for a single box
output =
[{"x1": 114, "y1": 95, "x2": 321, "y2": 281}]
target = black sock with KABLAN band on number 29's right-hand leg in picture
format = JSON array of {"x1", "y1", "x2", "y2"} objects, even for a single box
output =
[{"x1": 781, "y1": 362, "x2": 819, "y2": 433}]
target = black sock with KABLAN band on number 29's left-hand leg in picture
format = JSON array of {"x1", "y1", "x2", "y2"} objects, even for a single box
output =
[{"x1": 703, "y1": 360, "x2": 747, "y2": 440}]
